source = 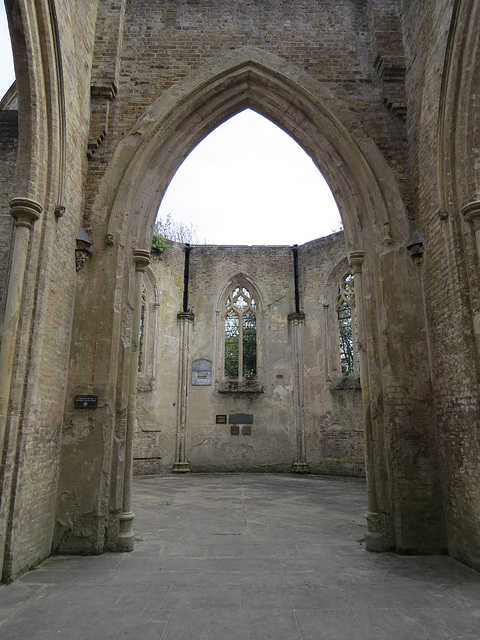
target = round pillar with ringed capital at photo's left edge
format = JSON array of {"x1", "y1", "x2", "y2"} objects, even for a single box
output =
[{"x1": 0, "y1": 198, "x2": 42, "y2": 576}]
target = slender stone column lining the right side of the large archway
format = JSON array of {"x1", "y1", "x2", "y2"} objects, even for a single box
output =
[{"x1": 348, "y1": 251, "x2": 386, "y2": 551}]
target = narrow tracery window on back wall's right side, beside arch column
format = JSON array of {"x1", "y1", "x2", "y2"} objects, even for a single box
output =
[{"x1": 336, "y1": 272, "x2": 359, "y2": 373}]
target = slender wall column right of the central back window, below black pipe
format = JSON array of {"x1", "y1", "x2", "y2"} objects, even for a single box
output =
[{"x1": 288, "y1": 313, "x2": 308, "y2": 473}]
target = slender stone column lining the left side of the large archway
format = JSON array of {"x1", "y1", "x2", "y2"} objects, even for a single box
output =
[{"x1": 117, "y1": 249, "x2": 150, "y2": 551}]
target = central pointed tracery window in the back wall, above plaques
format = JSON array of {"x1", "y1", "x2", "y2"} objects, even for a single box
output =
[{"x1": 224, "y1": 284, "x2": 258, "y2": 380}]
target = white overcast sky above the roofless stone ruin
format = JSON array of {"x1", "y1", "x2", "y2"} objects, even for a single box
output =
[{"x1": 0, "y1": 1, "x2": 340, "y2": 245}]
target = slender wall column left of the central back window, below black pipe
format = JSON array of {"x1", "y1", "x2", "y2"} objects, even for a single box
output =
[{"x1": 172, "y1": 311, "x2": 195, "y2": 473}]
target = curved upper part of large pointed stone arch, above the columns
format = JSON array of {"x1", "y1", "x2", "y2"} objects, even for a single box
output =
[{"x1": 94, "y1": 47, "x2": 408, "y2": 255}]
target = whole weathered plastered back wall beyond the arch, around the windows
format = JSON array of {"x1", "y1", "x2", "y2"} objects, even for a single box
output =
[{"x1": 134, "y1": 233, "x2": 365, "y2": 475}]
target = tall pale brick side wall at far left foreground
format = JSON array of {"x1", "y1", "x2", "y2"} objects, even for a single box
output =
[{"x1": 0, "y1": 0, "x2": 100, "y2": 578}]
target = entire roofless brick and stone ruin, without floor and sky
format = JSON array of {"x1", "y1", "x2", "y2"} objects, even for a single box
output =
[{"x1": 0, "y1": 0, "x2": 480, "y2": 581}]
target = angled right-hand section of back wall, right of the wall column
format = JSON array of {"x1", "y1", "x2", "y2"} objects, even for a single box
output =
[{"x1": 299, "y1": 232, "x2": 365, "y2": 475}]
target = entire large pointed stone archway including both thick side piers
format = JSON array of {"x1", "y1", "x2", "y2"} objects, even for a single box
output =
[{"x1": 59, "y1": 48, "x2": 445, "y2": 553}]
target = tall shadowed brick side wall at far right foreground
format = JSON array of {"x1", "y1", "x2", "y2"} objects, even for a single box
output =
[{"x1": 403, "y1": 0, "x2": 480, "y2": 567}]
